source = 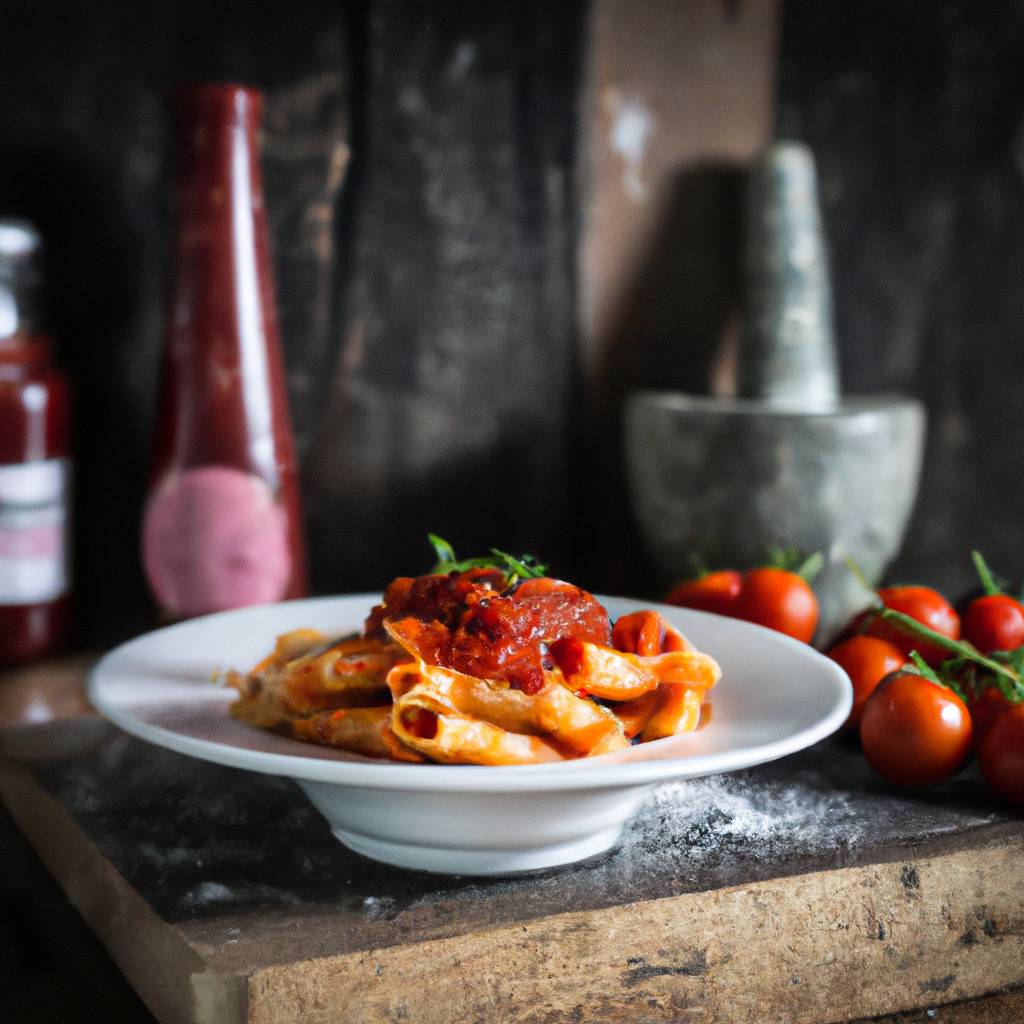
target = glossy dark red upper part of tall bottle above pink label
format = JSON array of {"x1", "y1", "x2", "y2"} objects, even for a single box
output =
[{"x1": 156, "y1": 85, "x2": 290, "y2": 485}]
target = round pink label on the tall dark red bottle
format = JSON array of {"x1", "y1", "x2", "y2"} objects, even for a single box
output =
[{"x1": 142, "y1": 466, "x2": 292, "y2": 615}]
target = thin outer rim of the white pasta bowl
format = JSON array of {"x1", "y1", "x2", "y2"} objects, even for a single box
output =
[{"x1": 85, "y1": 593, "x2": 853, "y2": 794}]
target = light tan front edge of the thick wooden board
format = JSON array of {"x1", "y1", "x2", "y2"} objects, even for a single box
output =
[{"x1": 249, "y1": 834, "x2": 1024, "y2": 1024}]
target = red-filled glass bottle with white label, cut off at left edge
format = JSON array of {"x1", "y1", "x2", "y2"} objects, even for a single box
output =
[{"x1": 0, "y1": 220, "x2": 71, "y2": 666}]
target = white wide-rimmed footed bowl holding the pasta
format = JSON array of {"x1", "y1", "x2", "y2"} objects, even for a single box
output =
[{"x1": 88, "y1": 595, "x2": 852, "y2": 874}]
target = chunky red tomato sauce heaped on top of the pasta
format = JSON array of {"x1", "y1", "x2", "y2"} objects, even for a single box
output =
[{"x1": 366, "y1": 569, "x2": 611, "y2": 693}]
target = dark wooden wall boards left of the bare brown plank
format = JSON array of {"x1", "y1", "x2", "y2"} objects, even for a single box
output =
[{"x1": 0, "y1": 0, "x2": 584, "y2": 643}]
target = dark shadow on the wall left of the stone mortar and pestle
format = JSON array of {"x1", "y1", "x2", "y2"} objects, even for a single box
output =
[{"x1": 580, "y1": 162, "x2": 746, "y2": 596}]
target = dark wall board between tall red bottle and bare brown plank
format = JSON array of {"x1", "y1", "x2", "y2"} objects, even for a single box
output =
[{"x1": 306, "y1": 0, "x2": 583, "y2": 592}]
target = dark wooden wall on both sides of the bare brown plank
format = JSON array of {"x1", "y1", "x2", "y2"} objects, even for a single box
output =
[{"x1": 0, "y1": 0, "x2": 1024, "y2": 643}]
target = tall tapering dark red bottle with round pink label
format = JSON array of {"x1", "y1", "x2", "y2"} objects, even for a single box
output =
[{"x1": 142, "y1": 84, "x2": 306, "y2": 618}]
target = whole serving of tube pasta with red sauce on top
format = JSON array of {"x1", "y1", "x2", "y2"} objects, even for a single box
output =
[{"x1": 226, "y1": 556, "x2": 720, "y2": 765}]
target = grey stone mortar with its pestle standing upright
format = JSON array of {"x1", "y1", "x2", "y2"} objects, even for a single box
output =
[{"x1": 625, "y1": 142, "x2": 925, "y2": 638}]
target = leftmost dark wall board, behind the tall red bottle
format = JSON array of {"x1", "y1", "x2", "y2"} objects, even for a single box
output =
[{"x1": 0, "y1": 0, "x2": 360, "y2": 643}]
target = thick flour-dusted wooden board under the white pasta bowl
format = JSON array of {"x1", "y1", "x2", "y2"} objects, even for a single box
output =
[{"x1": 0, "y1": 655, "x2": 1024, "y2": 1024}]
